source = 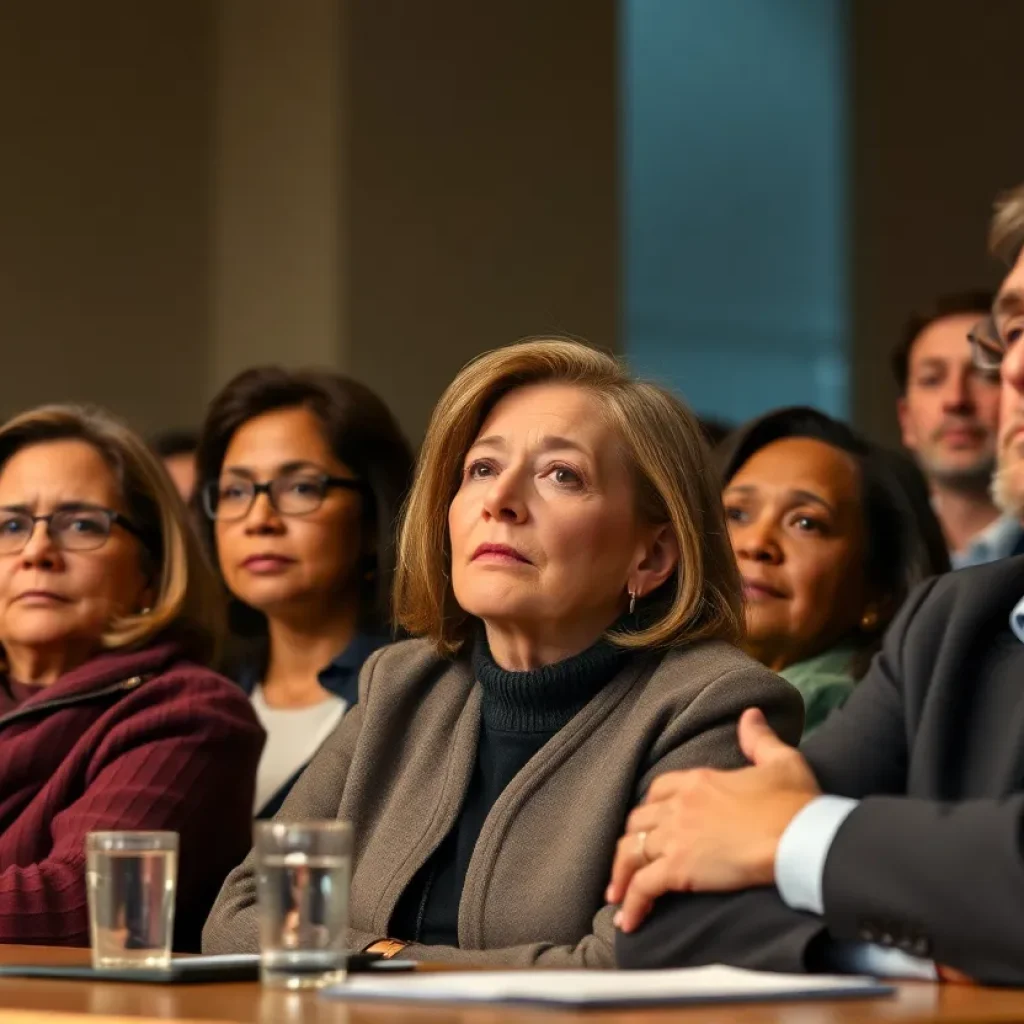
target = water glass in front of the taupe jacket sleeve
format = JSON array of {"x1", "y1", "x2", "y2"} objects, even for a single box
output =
[{"x1": 256, "y1": 821, "x2": 352, "y2": 989}]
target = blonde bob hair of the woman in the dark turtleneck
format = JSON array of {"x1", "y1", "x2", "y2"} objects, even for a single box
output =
[{"x1": 394, "y1": 339, "x2": 742, "y2": 655}]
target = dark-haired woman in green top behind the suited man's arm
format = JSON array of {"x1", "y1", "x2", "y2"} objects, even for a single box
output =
[{"x1": 722, "y1": 408, "x2": 949, "y2": 736}]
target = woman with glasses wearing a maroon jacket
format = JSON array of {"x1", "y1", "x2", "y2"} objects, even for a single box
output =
[{"x1": 0, "y1": 406, "x2": 263, "y2": 949}]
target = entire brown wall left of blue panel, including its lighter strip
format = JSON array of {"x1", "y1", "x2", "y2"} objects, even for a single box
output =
[{"x1": 0, "y1": 0, "x2": 618, "y2": 440}]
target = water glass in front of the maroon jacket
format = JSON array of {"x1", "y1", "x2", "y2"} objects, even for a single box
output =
[{"x1": 85, "y1": 831, "x2": 178, "y2": 971}]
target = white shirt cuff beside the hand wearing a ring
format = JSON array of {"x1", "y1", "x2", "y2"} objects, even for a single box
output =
[{"x1": 775, "y1": 797, "x2": 857, "y2": 914}]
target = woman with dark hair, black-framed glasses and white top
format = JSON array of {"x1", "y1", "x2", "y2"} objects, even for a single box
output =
[{"x1": 198, "y1": 367, "x2": 412, "y2": 817}]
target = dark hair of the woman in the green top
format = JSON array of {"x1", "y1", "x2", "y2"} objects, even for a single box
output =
[{"x1": 718, "y1": 406, "x2": 949, "y2": 679}]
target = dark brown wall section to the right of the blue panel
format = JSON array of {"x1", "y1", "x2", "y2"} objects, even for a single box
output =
[{"x1": 849, "y1": 0, "x2": 1024, "y2": 440}]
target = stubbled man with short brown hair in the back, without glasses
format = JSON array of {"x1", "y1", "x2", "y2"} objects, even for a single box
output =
[{"x1": 892, "y1": 291, "x2": 1022, "y2": 568}]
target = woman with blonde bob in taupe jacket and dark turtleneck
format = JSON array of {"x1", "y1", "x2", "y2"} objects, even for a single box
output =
[{"x1": 204, "y1": 340, "x2": 802, "y2": 967}]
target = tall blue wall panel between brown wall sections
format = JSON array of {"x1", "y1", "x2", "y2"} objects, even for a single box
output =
[{"x1": 621, "y1": 0, "x2": 848, "y2": 421}]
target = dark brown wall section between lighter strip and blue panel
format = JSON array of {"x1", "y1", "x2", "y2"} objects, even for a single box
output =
[{"x1": 346, "y1": 0, "x2": 618, "y2": 439}]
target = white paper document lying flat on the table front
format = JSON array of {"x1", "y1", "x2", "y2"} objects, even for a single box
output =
[{"x1": 324, "y1": 966, "x2": 894, "y2": 1008}]
